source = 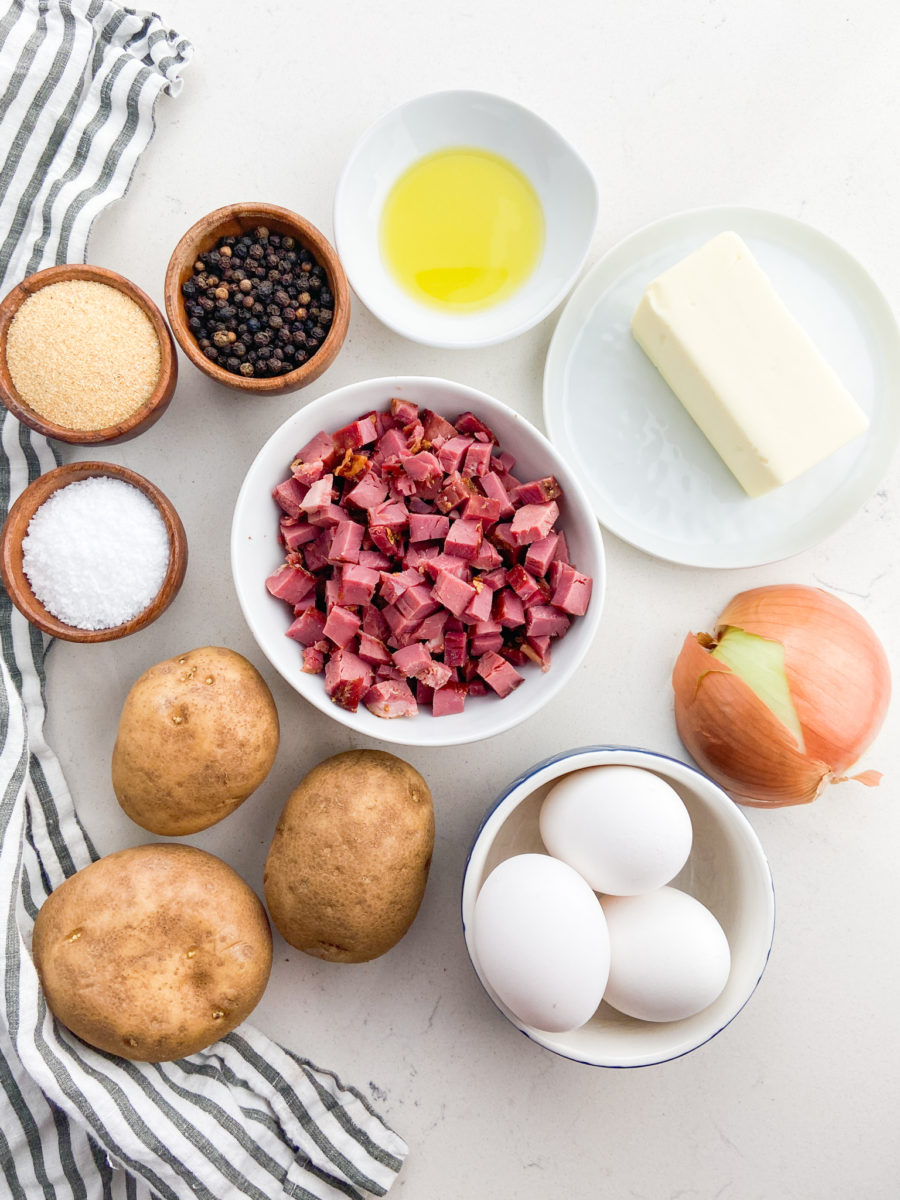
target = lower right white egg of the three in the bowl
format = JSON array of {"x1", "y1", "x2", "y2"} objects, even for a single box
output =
[{"x1": 601, "y1": 888, "x2": 731, "y2": 1021}]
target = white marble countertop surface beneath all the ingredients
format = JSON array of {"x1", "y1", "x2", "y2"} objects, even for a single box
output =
[{"x1": 48, "y1": 0, "x2": 900, "y2": 1200}]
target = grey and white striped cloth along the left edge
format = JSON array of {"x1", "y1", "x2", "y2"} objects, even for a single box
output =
[{"x1": 0, "y1": 0, "x2": 407, "y2": 1200}]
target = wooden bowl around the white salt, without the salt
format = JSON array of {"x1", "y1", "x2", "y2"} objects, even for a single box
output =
[{"x1": 0, "y1": 462, "x2": 187, "y2": 642}]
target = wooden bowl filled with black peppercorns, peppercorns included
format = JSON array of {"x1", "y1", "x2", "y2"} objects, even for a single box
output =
[{"x1": 164, "y1": 204, "x2": 350, "y2": 396}]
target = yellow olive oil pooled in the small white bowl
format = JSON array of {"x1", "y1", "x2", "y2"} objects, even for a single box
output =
[{"x1": 380, "y1": 146, "x2": 544, "y2": 312}]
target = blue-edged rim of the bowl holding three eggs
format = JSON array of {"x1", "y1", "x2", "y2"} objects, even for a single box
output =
[{"x1": 460, "y1": 744, "x2": 775, "y2": 1070}]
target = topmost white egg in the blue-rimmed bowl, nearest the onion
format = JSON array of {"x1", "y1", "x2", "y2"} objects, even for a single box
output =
[{"x1": 540, "y1": 766, "x2": 694, "y2": 895}]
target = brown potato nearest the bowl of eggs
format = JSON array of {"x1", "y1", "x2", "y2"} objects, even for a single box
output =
[{"x1": 264, "y1": 750, "x2": 434, "y2": 962}]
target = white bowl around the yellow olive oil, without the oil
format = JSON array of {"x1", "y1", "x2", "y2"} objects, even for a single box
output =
[{"x1": 334, "y1": 91, "x2": 598, "y2": 347}]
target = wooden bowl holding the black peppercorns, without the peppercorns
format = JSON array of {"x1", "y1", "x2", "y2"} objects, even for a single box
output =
[{"x1": 164, "y1": 204, "x2": 350, "y2": 396}]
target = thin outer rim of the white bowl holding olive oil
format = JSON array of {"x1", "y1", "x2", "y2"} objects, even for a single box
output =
[{"x1": 332, "y1": 88, "x2": 600, "y2": 349}]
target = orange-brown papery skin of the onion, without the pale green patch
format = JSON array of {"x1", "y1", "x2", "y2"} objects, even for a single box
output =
[{"x1": 672, "y1": 584, "x2": 890, "y2": 806}]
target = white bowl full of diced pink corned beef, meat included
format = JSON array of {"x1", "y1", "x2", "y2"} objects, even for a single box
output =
[{"x1": 232, "y1": 377, "x2": 605, "y2": 745}]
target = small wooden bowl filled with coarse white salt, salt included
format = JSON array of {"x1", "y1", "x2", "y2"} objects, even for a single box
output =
[{"x1": 0, "y1": 462, "x2": 187, "y2": 642}]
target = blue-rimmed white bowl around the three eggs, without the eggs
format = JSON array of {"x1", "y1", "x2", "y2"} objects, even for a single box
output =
[{"x1": 462, "y1": 746, "x2": 775, "y2": 1067}]
